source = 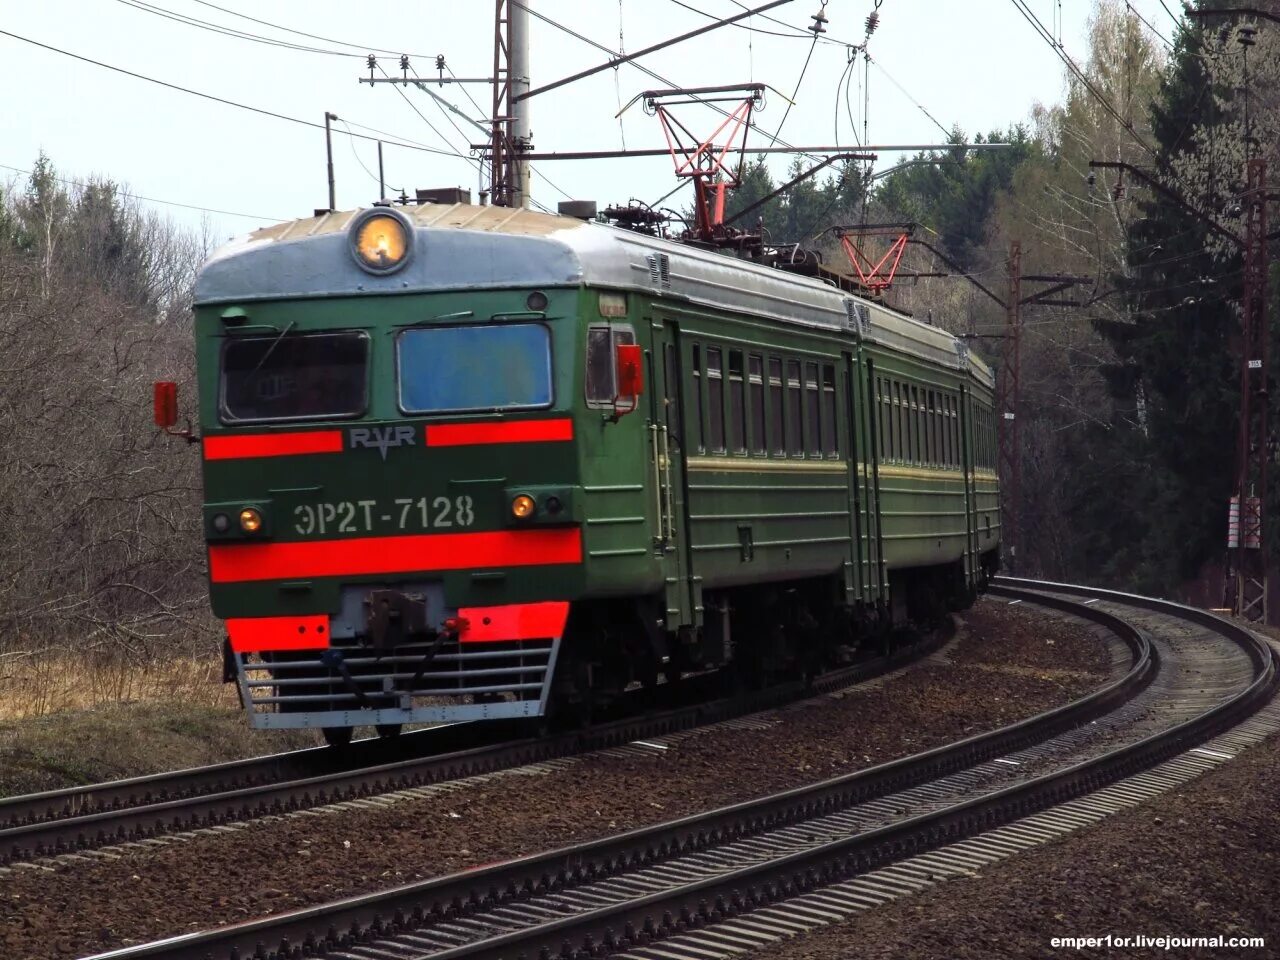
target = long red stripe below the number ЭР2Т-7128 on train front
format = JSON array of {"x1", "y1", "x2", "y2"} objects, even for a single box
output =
[{"x1": 209, "y1": 527, "x2": 582, "y2": 584}]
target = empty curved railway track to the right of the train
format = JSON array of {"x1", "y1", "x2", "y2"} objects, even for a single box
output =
[{"x1": 82, "y1": 580, "x2": 1276, "y2": 960}]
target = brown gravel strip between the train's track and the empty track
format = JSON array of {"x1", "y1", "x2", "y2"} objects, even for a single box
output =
[{"x1": 0, "y1": 599, "x2": 1112, "y2": 960}]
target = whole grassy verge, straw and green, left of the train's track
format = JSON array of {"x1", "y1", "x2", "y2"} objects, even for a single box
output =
[{"x1": 0, "y1": 652, "x2": 319, "y2": 795}]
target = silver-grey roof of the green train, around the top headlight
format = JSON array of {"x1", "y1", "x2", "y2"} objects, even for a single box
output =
[{"x1": 196, "y1": 204, "x2": 991, "y2": 383}]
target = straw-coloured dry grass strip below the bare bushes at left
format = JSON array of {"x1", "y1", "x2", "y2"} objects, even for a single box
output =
[{"x1": 0, "y1": 650, "x2": 237, "y2": 721}]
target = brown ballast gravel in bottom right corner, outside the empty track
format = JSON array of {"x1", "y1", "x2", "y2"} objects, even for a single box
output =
[{"x1": 755, "y1": 737, "x2": 1280, "y2": 960}]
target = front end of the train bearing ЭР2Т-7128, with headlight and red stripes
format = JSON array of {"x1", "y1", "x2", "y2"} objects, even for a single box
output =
[{"x1": 196, "y1": 206, "x2": 644, "y2": 742}]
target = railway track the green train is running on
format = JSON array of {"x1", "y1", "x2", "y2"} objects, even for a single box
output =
[{"x1": 0, "y1": 635, "x2": 942, "y2": 867}]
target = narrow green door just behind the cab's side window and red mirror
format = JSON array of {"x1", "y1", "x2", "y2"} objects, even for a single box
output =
[{"x1": 649, "y1": 317, "x2": 698, "y2": 630}]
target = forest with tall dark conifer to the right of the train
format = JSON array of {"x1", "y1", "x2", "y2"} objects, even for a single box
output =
[{"x1": 733, "y1": 0, "x2": 1280, "y2": 605}]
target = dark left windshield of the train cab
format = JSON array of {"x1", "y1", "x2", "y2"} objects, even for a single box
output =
[{"x1": 220, "y1": 330, "x2": 369, "y2": 424}]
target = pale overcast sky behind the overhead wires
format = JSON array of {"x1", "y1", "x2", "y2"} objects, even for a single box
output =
[{"x1": 0, "y1": 0, "x2": 1178, "y2": 238}]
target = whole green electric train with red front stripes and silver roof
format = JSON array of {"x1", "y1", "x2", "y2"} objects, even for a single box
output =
[{"x1": 167, "y1": 204, "x2": 1000, "y2": 741}]
